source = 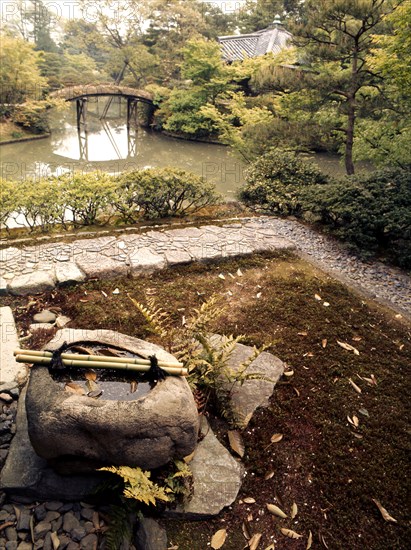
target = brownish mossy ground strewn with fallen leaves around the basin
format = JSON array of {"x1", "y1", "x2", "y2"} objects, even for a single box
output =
[{"x1": 2, "y1": 253, "x2": 411, "y2": 550}]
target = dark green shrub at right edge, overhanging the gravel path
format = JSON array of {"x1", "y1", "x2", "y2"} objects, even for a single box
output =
[{"x1": 304, "y1": 168, "x2": 411, "y2": 268}]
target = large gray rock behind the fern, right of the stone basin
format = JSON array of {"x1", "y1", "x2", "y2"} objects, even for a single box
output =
[{"x1": 210, "y1": 334, "x2": 284, "y2": 427}]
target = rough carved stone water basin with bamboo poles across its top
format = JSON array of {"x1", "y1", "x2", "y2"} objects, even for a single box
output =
[{"x1": 26, "y1": 329, "x2": 199, "y2": 473}]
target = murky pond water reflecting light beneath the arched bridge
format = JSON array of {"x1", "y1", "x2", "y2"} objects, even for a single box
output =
[{"x1": 0, "y1": 100, "x2": 374, "y2": 199}]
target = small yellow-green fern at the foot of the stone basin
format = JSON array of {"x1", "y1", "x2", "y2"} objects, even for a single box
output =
[{"x1": 100, "y1": 466, "x2": 170, "y2": 506}]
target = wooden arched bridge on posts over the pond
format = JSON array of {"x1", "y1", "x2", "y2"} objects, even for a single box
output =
[{"x1": 51, "y1": 84, "x2": 153, "y2": 130}]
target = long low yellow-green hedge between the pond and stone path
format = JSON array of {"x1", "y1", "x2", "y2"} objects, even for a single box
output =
[{"x1": 0, "y1": 168, "x2": 220, "y2": 232}]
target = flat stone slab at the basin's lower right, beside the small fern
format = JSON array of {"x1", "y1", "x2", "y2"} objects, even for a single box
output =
[{"x1": 166, "y1": 417, "x2": 244, "y2": 520}]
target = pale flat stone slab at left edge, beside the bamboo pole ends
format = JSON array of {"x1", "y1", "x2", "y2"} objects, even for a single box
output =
[{"x1": 0, "y1": 307, "x2": 27, "y2": 382}]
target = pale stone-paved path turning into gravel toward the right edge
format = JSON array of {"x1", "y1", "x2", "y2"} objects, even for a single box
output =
[{"x1": 0, "y1": 217, "x2": 411, "y2": 317}]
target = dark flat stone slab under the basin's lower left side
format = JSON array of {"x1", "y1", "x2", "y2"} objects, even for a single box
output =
[{"x1": 0, "y1": 388, "x2": 104, "y2": 501}]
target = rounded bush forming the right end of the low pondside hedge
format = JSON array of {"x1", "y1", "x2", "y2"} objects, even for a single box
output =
[{"x1": 114, "y1": 168, "x2": 220, "y2": 223}]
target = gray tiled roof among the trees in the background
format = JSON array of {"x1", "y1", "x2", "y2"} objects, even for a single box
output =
[{"x1": 218, "y1": 25, "x2": 292, "y2": 61}]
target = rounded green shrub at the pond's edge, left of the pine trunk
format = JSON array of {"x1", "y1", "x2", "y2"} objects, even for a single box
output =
[{"x1": 239, "y1": 149, "x2": 328, "y2": 216}]
